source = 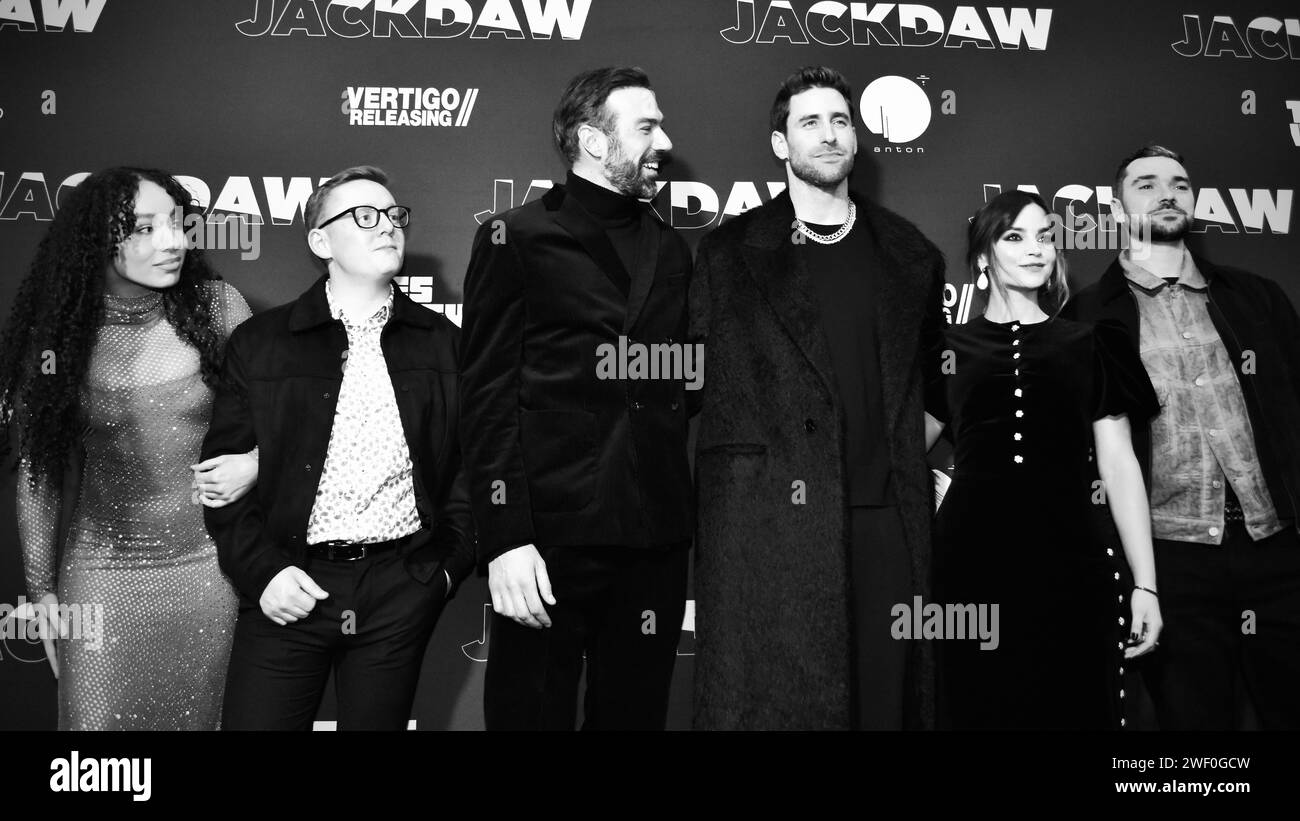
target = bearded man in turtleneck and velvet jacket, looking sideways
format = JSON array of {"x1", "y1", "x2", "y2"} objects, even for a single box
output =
[{"x1": 460, "y1": 68, "x2": 697, "y2": 730}]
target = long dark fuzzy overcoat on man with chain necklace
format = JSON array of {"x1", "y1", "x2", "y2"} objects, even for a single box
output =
[{"x1": 690, "y1": 194, "x2": 944, "y2": 729}]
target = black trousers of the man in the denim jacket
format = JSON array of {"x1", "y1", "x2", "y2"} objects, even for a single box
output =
[{"x1": 1143, "y1": 524, "x2": 1300, "y2": 730}]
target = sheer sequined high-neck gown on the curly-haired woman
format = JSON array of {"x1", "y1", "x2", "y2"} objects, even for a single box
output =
[{"x1": 18, "y1": 282, "x2": 250, "y2": 730}]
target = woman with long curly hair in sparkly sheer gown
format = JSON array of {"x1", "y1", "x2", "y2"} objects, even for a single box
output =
[{"x1": 0, "y1": 168, "x2": 257, "y2": 730}]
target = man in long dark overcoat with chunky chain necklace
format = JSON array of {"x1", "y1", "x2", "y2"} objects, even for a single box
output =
[{"x1": 690, "y1": 68, "x2": 944, "y2": 729}]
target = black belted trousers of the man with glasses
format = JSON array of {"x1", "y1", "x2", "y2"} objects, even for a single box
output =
[{"x1": 221, "y1": 549, "x2": 447, "y2": 730}]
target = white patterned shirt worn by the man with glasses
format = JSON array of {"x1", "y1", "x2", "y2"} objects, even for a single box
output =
[{"x1": 307, "y1": 279, "x2": 420, "y2": 544}]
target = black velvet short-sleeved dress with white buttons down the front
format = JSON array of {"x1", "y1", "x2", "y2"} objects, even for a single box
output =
[{"x1": 927, "y1": 317, "x2": 1158, "y2": 729}]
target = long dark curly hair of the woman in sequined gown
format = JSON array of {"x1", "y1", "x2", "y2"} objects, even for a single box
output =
[{"x1": 0, "y1": 168, "x2": 222, "y2": 490}]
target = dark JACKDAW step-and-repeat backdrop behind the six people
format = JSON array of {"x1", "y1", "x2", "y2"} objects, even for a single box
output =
[{"x1": 0, "y1": 0, "x2": 1300, "y2": 729}]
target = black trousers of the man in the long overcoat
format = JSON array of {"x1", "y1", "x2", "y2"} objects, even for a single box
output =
[{"x1": 849, "y1": 507, "x2": 913, "y2": 730}]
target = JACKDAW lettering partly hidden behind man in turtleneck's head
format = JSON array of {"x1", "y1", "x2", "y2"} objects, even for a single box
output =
[{"x1": 475, "y1": 179, "x2": 785, "y2": 229}]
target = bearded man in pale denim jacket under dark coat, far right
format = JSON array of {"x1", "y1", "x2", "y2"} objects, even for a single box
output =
[{"x1": 1063, "y1": 144, "x2": 1300, "y2": 730}]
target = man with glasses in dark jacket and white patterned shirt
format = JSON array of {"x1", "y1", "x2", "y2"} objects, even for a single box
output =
[{"x1": 203, "y1": 166, "x2": 473, "y2": 730}]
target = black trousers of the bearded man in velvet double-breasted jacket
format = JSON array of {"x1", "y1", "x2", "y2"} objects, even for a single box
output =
[{"x1": 484, "y1": 547, "x2": 689, "y2": 730}]
